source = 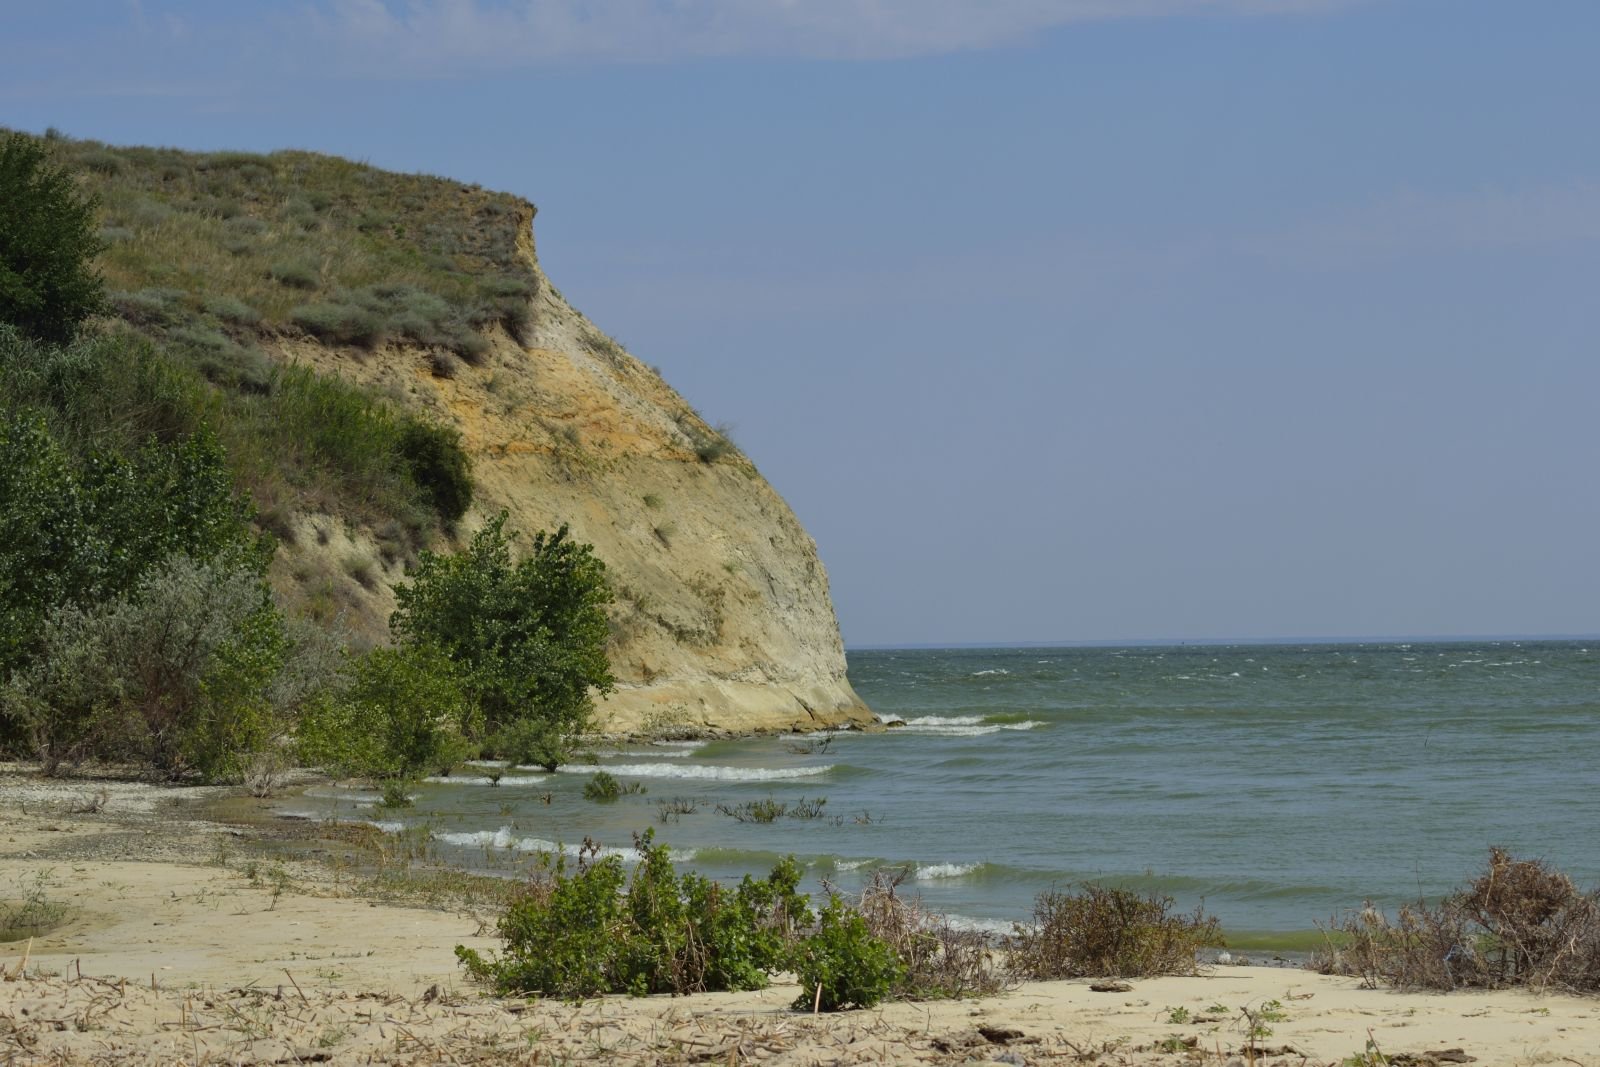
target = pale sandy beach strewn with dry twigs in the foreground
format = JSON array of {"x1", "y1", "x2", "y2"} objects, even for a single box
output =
[{"x1": 0, "y1": 769, "x2": 1600, "y2": 1067}]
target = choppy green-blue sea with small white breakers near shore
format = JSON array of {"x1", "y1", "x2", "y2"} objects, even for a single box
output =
[{"x1": 285, "y1": 640, "x2": 1600, "y2": 952}]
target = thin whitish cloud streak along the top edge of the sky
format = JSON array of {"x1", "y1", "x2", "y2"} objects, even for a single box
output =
[{"x1": 310, "y1": 0, "x2": 1374, "y2": 69}]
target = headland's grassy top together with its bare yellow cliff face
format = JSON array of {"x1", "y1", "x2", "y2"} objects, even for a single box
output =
[{"x1": 56, "y1": 139, "x2": 870, "y2": 731}]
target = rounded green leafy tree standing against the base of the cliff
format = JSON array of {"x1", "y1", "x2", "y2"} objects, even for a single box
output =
[{"x1": 389, "y1": 512, "x2": 614, "y2": 769}]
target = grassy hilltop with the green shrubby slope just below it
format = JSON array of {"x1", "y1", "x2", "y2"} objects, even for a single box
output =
[{"x1": 32, "y1": 134, "x2": 550, "y2": 588}]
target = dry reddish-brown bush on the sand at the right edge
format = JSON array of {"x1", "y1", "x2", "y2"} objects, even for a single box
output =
[{"x1": 1312, "y1": 848, "x2": 1600, "y2": 993}]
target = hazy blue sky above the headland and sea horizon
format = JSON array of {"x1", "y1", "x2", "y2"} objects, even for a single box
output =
[{"x1": 0, "y1": 0, "x2": 1600, "y2": 646}]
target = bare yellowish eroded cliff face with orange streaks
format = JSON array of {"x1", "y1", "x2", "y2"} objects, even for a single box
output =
[{"x1": 275, "y1": 205, "x2": 870, "y2": 731}]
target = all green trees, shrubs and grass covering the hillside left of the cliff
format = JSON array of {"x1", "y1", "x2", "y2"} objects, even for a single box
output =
[{"x1": 0, "y1": 134, "x2": 610, "y2": 783}]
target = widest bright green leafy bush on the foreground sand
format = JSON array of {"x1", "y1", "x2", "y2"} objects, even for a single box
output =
[{"x1": 456, "y1": 833, "x2": 811, "y2": 998}]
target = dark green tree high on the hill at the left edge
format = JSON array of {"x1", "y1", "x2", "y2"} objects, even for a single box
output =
[{"x1": 0, "y1": 133, "x2": 104, "y2": 341}]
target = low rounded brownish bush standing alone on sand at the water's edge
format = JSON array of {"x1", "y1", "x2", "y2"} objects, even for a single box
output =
[{"x1": 1008, "y1": 885, "x2": 1222, "y2": 979}]
